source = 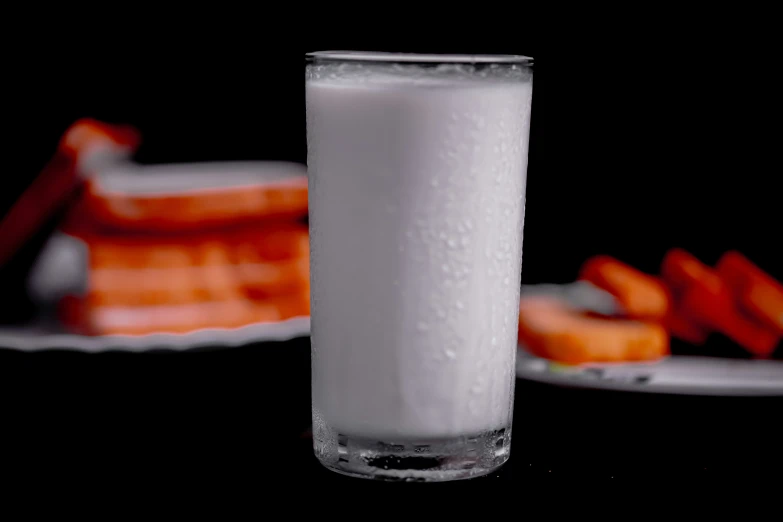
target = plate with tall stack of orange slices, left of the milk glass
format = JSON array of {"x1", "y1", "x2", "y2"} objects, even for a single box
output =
[{"x1": 0, "y1": 120, "x2": 310, "y2": 351}]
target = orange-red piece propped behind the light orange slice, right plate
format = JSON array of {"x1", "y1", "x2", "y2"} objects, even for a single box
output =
[{"x1": 579, "y1": 256, "x2": 670, "y2": 319}]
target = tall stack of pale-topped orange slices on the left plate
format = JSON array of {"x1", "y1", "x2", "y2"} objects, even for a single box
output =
[{"x1": 36, "y1": 120, "x2": 310, "y2": 335}]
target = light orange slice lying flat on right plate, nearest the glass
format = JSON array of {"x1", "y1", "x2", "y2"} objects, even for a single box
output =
[{"x1": 519, "y1": 297, "x2": 669, "y2": 364}]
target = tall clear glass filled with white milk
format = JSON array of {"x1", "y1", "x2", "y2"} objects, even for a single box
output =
[{"x1": 306, "y1": 52, "x2": 533, "y2": 481}]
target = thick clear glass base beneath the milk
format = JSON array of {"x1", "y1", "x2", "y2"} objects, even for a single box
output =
[{"x1": 313, "y1": 426, "x2": 511, "y2": 482}]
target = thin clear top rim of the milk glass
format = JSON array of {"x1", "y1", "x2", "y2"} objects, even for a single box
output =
[{"x1": 305, "y1": 51, "x2": 533, "y2": 66}]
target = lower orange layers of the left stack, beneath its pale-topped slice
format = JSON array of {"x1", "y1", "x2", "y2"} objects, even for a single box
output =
[{"x1": 61, "y1": 224, "x2": 309, "y2": 335}]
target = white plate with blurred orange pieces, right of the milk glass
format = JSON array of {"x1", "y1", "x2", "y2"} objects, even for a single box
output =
[{"x1": 517, "y1": 253, "x2": 783, "y2": 396}]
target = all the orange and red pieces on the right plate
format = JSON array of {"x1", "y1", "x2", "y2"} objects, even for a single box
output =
[{"x1": 519, "y1": 249, "x2": 783, "y2": 364}]
